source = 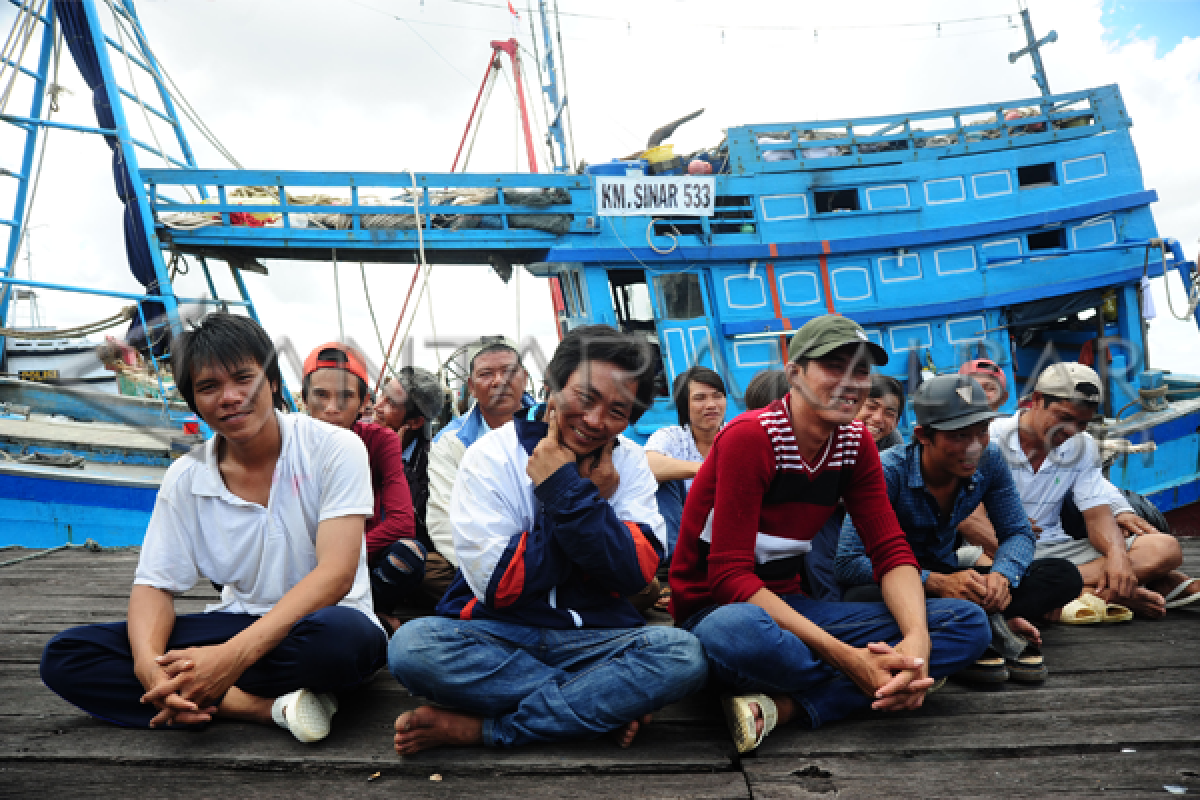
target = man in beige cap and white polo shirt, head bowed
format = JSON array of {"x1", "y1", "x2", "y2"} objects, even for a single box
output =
[{"x1": 991, "y1": 362, "x2": 1183, "y2": 618}]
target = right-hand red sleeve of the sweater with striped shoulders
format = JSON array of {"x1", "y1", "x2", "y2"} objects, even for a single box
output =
[{"x1": 844, "y1": 422, "x2": 920, "y2": 583}]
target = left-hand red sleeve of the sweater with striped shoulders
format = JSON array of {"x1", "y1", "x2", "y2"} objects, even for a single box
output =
[{"x1": 692, "y1": 416, "x2": 775, "y2": 606}]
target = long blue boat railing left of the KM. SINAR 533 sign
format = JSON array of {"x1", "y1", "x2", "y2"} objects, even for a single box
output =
[{"x1": 142, "y1": 168, "x2": 598, "y2": 243}]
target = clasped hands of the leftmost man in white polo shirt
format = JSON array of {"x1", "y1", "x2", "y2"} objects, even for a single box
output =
[{"x1": 138, "y1": 644, "x2": 244, "y2": 728}]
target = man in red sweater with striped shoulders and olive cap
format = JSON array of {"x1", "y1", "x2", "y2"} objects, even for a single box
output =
[{"x1": 671, "y1": 314, "x2": 991, "y2": 752}]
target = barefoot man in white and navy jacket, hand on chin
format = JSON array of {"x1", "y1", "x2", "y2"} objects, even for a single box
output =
[{"x1": 389, "y1": 325, "x2": 706, "y2": 756}]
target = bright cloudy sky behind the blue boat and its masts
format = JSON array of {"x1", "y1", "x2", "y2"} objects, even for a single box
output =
[{"x1": 0, "y1": 0, "x2": 1200, "y2": 388}]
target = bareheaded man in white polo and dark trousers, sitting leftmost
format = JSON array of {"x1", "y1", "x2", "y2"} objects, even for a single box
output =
[{"x1": 41, "y1": 313, "x2": 388, "y2": 741}]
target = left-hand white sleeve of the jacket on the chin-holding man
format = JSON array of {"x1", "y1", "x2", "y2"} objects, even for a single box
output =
[{"x1": 450, "y1": 438, "x2": 528, "y2": 601}]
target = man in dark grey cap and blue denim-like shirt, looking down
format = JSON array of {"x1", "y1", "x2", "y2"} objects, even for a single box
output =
[{"x1": 834, "y1": 374, "x2": 1082, "y2": 682}]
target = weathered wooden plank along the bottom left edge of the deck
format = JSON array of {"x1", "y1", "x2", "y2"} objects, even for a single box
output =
[{"x1": 0, "y1": 763, "x2": 750, "y2": 800}]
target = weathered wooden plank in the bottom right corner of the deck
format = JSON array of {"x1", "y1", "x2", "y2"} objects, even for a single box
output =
[{"x1": 742, "y1": 747, "x2": 1200, "y2": 800}]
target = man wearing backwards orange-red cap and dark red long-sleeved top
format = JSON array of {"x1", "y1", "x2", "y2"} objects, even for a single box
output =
[{"x1": 302, "y1": 342, "x2": 426, "y2": 630}]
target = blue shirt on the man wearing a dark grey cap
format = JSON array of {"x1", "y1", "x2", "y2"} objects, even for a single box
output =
[{"x1": 834, "y1": 441, "x2": 1036, "y2": 589}]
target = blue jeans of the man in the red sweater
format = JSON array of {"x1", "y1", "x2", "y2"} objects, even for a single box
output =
[{"x1": 686, "y1": 595, "x2": 991, "y2": 728}]
